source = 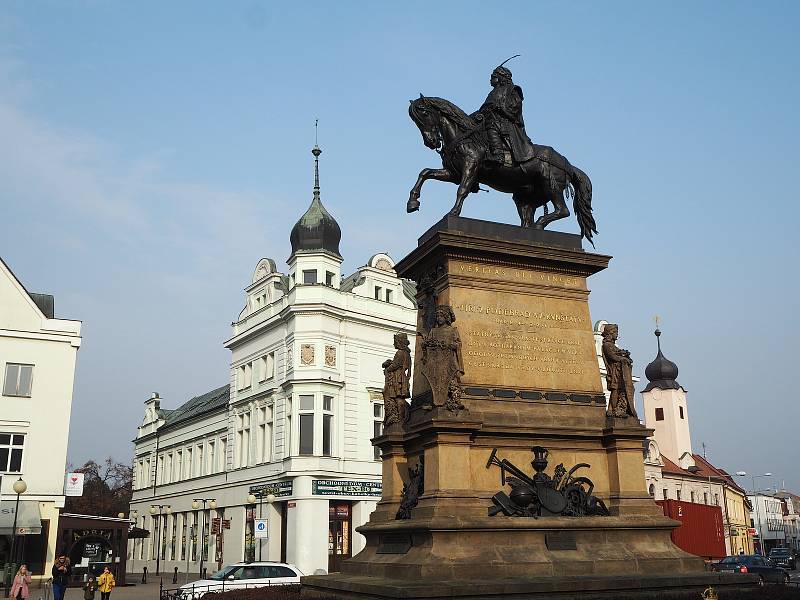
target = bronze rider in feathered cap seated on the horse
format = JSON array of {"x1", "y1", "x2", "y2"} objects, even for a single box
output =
[{"x1": 472, "y1": 65, "x2": 536, "y2": 165}]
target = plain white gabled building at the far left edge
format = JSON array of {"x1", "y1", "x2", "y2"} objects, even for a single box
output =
[{"x1": 0, "y1": 260, "x2": 81, "y2": 577}]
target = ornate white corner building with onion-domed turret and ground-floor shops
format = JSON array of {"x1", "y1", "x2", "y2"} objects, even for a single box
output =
[{"x1": 128, "y1": 148, "x2": 416, "y2": 574}]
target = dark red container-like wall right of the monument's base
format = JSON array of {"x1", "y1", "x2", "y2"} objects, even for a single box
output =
[{"x1": 656, "y1": 500, "x2": 726, "y2": 558}]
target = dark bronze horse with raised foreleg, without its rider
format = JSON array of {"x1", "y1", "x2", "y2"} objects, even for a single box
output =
[{"x1": 406, "y1": 94, "x2": 597, "y2": 246}]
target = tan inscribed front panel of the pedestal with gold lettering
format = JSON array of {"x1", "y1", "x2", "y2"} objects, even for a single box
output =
[{"x1": 449, "y1": 261, "x2": 602, "y2": 393}]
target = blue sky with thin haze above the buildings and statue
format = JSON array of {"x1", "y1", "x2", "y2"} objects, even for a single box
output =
[{"x1": 0, "y1": 1, "x2": 800, "y2": 491}]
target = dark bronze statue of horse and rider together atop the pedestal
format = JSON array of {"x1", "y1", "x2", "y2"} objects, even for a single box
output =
[{"x1": 406, "y1": 57, "x2": 597, "y2": 246}]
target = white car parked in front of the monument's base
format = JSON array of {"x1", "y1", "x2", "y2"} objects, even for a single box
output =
[{"x1": 178, "y1": 562, "x2": 303, "y2": 600}]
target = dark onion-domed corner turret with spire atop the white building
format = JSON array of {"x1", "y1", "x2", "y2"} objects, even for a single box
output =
[{"x1": 287, "y1": 145, "x2": 342, "y2": 289}]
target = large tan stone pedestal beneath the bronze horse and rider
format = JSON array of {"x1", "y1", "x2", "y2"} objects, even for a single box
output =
[{"x1": 303, "y1": 217, "x2": 752, "y2": 599}]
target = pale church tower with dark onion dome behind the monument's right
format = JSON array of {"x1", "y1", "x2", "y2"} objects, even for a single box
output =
[{"x1": 642, "y1": 329, "x2": 694, "y2": 469}]
